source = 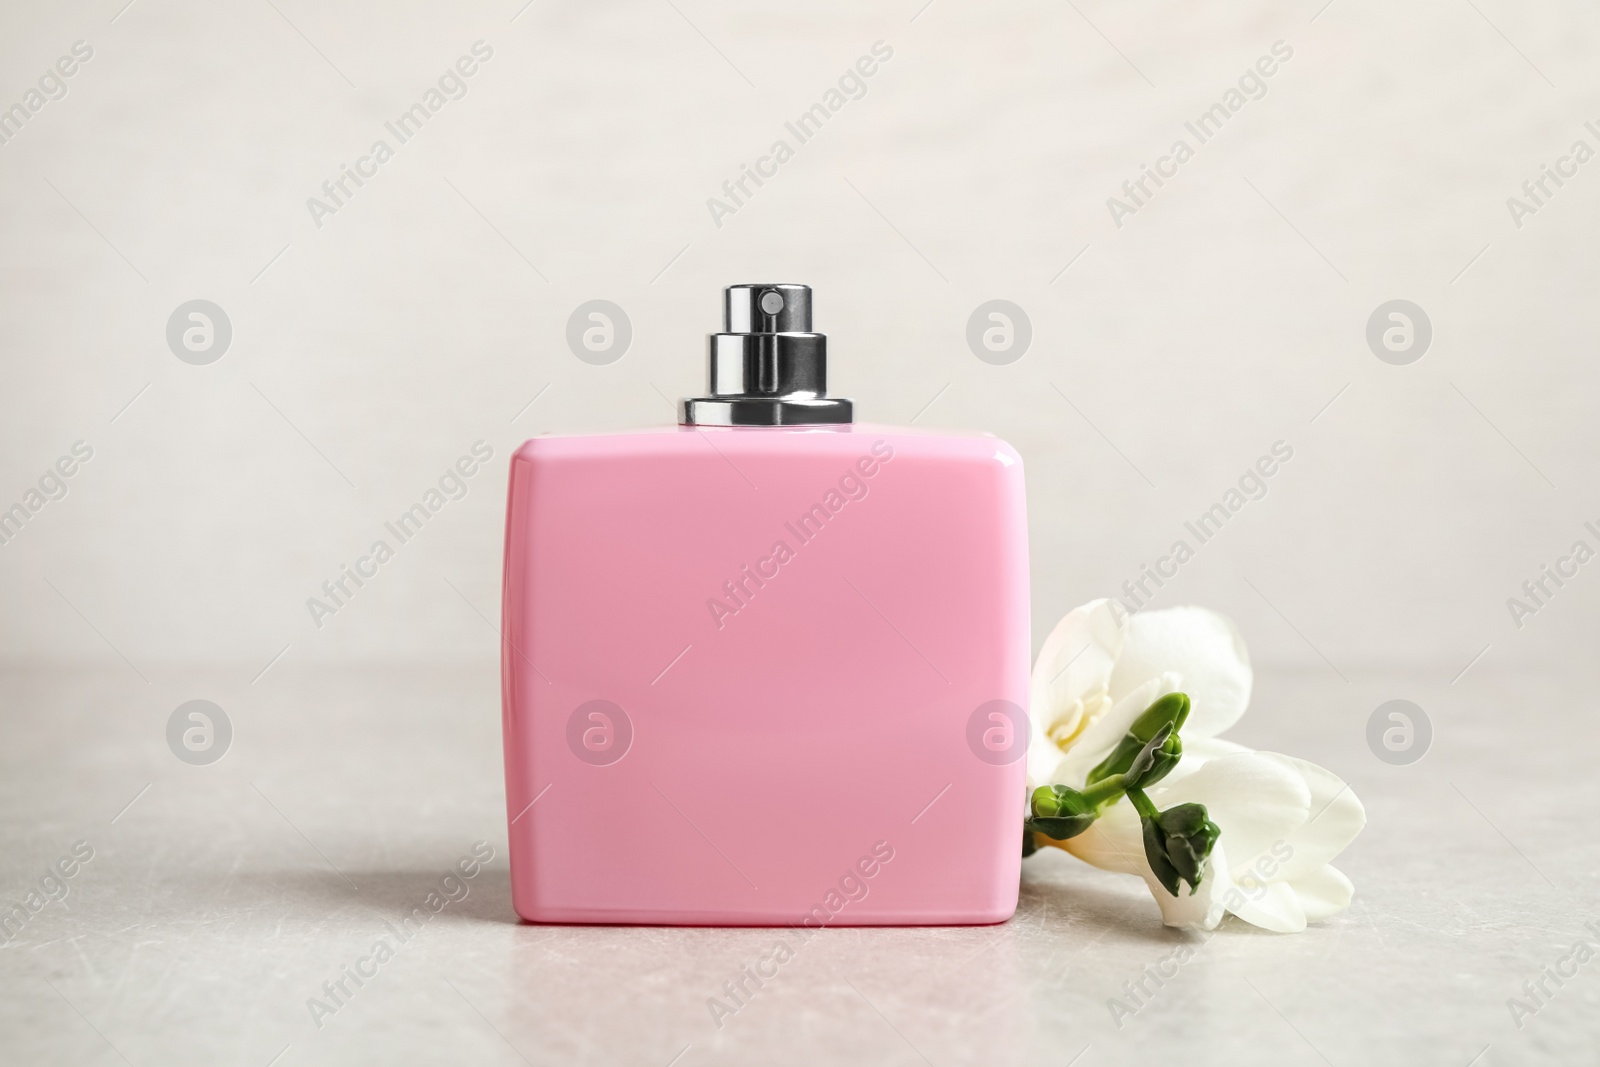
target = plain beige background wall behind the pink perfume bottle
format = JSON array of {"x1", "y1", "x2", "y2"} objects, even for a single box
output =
[{"x1": 0, "y1": 0, "x2": 1600, "y2": 686}]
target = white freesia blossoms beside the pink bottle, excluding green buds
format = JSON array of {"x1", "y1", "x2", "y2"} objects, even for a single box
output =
[{"x1": 1027, "y1": 600, "x2": 1366, "y2": 933}]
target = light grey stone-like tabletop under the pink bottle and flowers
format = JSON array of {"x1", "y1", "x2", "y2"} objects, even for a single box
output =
[{"x1": 0, "y1": 664, "x2": 1600, "y2": 1067}]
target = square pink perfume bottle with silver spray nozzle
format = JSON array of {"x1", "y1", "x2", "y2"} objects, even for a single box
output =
[{"x1": 502, "y1": 285, "x2": 1030, "y2": 928}]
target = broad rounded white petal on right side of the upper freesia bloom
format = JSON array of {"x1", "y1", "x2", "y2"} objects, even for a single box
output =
[{"x1": 1110, "y1": 608, "x2": 1254, "y2": 741}]
